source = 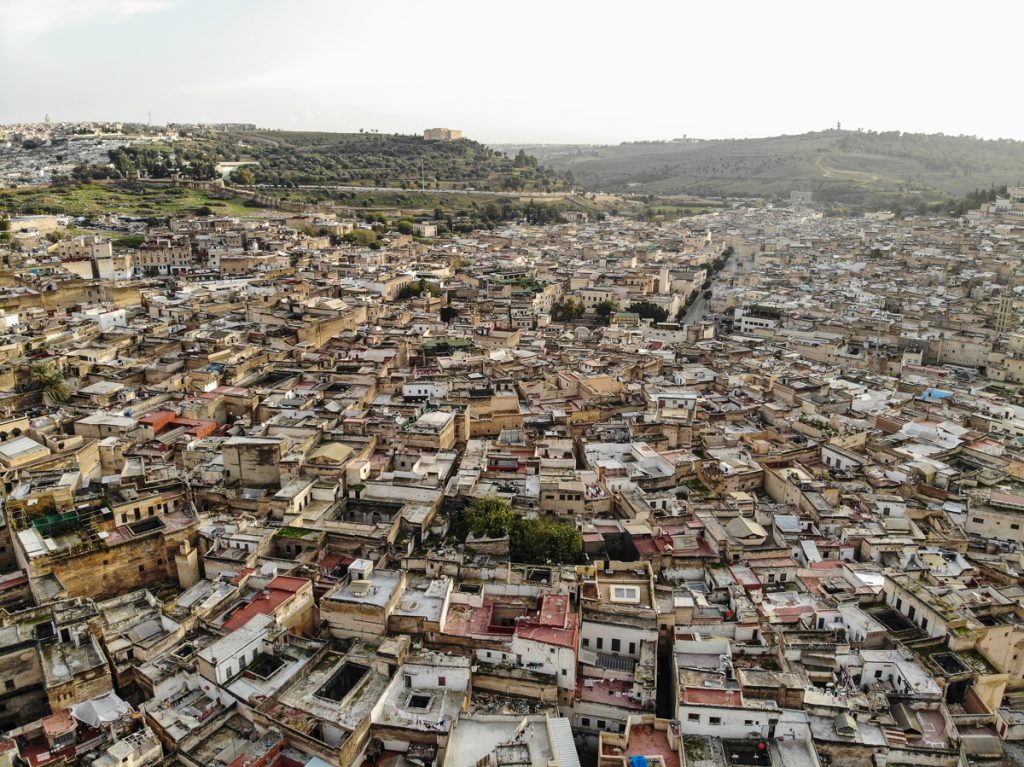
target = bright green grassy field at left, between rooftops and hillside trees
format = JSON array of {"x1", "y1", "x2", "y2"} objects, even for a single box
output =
[{"x1": 0, "y1": 181, "x2": 266, "y2": 218}]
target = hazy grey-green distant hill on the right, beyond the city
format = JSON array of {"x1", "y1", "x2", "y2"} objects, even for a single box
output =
[{"x1": 497, "y1": 130, "x2": 1024, "y2": 206}]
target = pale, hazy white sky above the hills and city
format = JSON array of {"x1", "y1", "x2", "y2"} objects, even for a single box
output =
[{"x1": 0, "y1": 0, "x2": 1024, "y2": 142}]
